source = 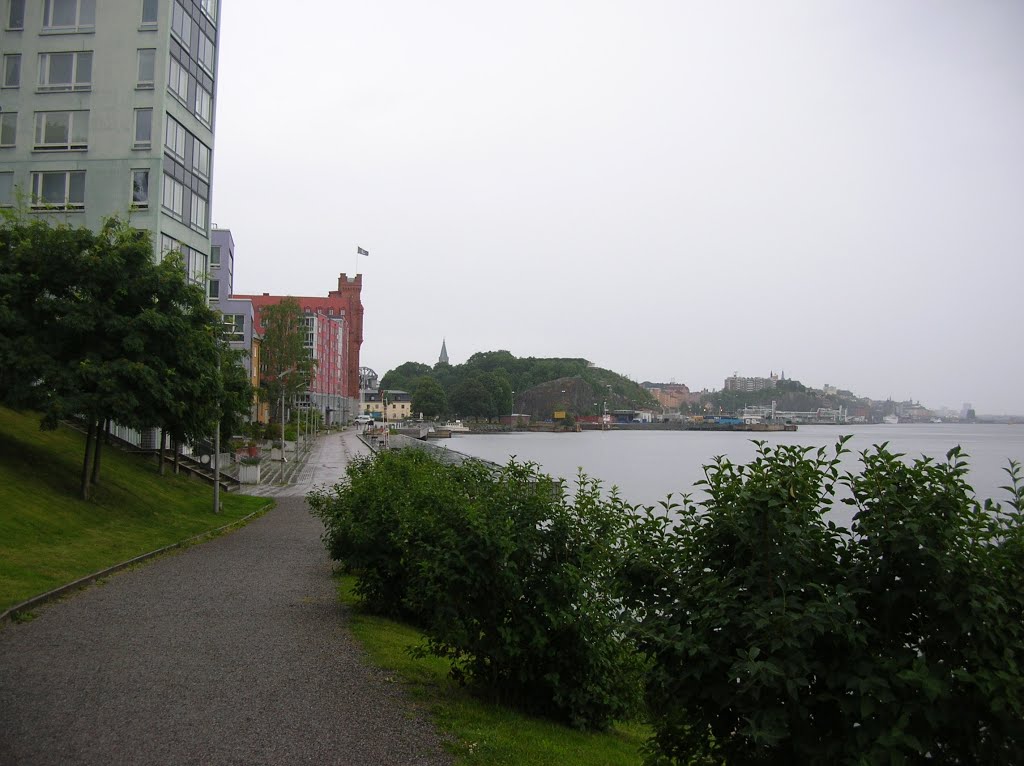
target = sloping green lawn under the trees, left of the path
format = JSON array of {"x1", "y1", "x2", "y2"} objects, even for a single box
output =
[{"x1": 0, "y1": 408, "x2": 268, "y2": 611}]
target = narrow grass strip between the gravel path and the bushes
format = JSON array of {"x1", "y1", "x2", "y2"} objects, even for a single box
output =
[{"x1": 338, "y1": 577, "x2": 650, "y2": 766}]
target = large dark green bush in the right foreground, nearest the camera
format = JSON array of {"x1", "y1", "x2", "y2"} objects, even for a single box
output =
[{"x1": 624, "y1": 443, "x2": 1024, "y2": 764}]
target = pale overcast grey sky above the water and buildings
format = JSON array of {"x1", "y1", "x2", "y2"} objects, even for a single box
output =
[{"x1": 212, "y1": 0, "x2": 1024, "y2": 413}]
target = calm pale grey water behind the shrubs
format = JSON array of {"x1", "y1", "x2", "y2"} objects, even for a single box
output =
[{"x1": 444, "y1": 424, "x2": 1024, "y2": 522}]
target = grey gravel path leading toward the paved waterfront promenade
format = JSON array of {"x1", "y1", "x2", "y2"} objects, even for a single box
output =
[{"x1": 0, "y1": 434, "x2": 451, "y2": 766}]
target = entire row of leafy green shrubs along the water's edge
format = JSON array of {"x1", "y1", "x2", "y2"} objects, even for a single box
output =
[{"x1": 311, "y1": 442, "x2": 1024, "y2": 764}]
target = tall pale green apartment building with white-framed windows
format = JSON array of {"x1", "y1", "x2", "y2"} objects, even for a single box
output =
[{"x1": 0, "y1": 0, "x2": 220, "y2": 284}]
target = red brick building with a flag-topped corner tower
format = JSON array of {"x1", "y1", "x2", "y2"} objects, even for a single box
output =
[{"x1": 231, "y1": 273, "x2": 362, "y2": 422}]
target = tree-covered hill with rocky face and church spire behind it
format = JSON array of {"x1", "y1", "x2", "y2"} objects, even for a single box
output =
[{"x1": 381, "y1": 350, "x2": 657, "y2": 418}]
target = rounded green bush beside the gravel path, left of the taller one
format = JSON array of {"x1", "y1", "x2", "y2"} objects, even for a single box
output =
[{"x1": 310, "y1": 451, "x2": 642, "y2": 728}]
